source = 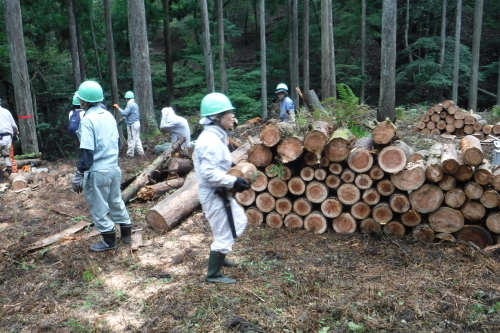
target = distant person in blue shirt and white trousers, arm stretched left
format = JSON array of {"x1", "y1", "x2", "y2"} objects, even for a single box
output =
[{"x1": 113, "y1": 91, "x2": 144, "y2": 158}]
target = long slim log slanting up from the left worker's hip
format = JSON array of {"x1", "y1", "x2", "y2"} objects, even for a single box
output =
[{"x1": 122, "y1": 136, "x2": 186, "y2": 202}]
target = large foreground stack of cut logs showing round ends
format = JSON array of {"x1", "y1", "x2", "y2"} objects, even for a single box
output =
[{"x1": 236, "y1": 119, "x2": 500, "y2": 247}]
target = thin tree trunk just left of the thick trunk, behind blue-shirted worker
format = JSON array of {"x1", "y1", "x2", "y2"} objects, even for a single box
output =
[{"x1": 103, "y1": 0, "x2": 125, "y2": 148}]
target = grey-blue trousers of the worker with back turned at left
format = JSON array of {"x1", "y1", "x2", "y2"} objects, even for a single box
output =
[{"x1": 83, "y1": 167, "x2": 131, "y2": 233}]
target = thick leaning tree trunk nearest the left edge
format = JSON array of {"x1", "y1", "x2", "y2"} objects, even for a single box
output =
[{"x1": 3, "y1": 0, "x2": 39, "y2": 154}]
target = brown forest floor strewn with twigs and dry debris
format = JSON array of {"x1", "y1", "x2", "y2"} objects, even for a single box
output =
[{"x1": 0, "y1": 109, "x2": 500, "y2": 333}]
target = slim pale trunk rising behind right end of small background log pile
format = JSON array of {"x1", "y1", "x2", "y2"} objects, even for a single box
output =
[{"x1": 469, "y1": 0, "x2": 484, "y2": 111}]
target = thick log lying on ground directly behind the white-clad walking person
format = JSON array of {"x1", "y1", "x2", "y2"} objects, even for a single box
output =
[{"x1": 146, "y1": 171, "x2": 200, "y2": 231}]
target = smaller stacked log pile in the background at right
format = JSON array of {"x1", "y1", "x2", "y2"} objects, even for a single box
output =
[{"x1": 415, "y1": 100, "x2": 492, "y2": 140}]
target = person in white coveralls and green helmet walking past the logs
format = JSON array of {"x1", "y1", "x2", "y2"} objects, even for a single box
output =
[{"x1": 193, "y1": 93, "x2": 249, "y2": 283}]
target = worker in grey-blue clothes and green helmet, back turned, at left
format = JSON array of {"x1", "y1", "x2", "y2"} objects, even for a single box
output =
[{"x1": 72, "y1": 81, "x2": 132, "y2": 252}]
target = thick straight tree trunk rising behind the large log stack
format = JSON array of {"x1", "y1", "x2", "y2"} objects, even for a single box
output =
[{"x1": 377, "y1": 0, "x2": 397, "y2": 121}]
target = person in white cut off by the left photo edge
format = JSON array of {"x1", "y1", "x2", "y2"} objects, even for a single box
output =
[{"x1": 0, "y1": 100, "x2": 19, "y2": 183}]
